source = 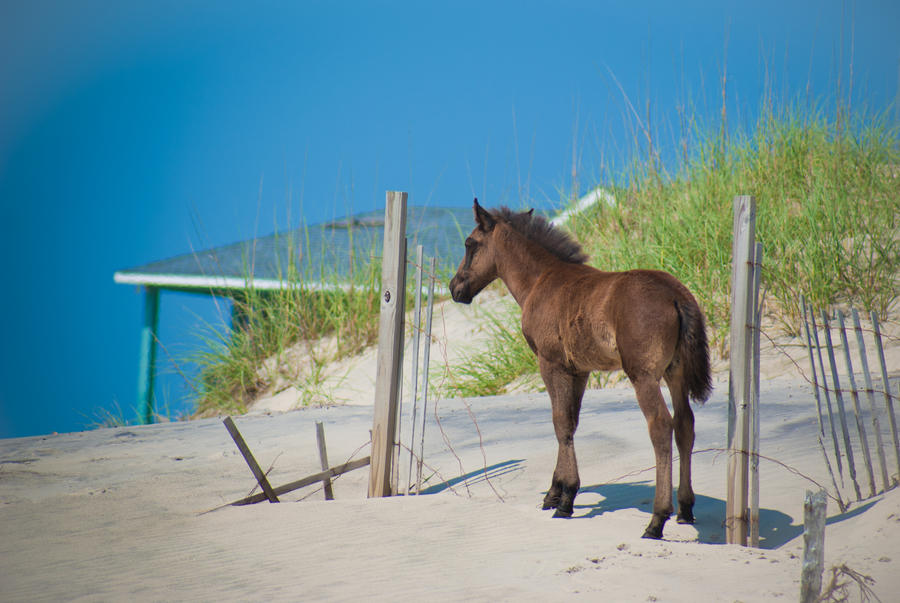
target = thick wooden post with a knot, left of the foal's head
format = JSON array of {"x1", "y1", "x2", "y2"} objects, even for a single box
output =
[{"x1": 369, "y1": 191, "x2": 407, "y2": 497}]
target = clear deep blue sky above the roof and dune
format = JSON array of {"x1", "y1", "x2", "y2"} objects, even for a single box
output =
[{"x1": 0, "y1": 0, "x2": 900, "y2": 437}]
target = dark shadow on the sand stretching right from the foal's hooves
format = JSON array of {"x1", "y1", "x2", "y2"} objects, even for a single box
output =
[{"x1": 573, "y1": 481, "x2": 878, "y2": 549}]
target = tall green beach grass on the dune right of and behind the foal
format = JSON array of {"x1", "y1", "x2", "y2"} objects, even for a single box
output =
[{"x1": 440, "y1": 105, "x2": 900, "y2": 396}]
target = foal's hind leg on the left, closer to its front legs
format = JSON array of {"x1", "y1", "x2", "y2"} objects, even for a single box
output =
[{"x1": 631, "y1": 375, "x2": 672, "y2": 539}]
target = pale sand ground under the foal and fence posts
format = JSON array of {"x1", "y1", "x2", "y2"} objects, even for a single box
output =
[{"x1": 0, "y1": 296, "x2": 900, "y2": 602}]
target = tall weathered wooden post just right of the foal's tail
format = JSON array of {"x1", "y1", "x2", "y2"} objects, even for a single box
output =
[{"x1": 725, "y1": 196, "x2": 756, "y2": 546}]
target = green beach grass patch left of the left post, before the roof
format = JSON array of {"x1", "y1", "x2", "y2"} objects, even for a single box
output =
[{"x1": 189, "y1": 228, "x2": 381, "y2": 416}]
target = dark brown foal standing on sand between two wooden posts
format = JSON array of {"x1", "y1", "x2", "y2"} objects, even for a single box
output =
[{"x1": 450, "y1": 199, "x2": 712, "y2": 538}]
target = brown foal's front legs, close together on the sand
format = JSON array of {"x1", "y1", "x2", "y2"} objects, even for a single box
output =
[{"x1": 540, "y1": 358, "x2": 588, "y2": 517}]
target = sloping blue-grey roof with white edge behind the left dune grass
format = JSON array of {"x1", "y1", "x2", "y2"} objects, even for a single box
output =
[{"x1": 114, "y1": 207, "x2": 474, "y2": 291}]
